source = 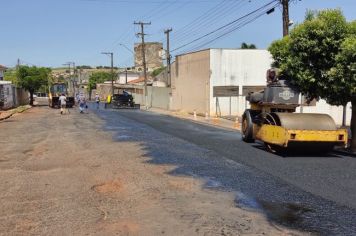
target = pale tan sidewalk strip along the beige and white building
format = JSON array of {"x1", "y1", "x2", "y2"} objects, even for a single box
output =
[{"x1": 145, "y1": 108, "x2": 241, "y2": 131}]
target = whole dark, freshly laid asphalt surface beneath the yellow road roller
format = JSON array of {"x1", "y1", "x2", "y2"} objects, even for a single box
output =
[{"x1": 95, "y1": 107, "x2": 356, "y2": 235}]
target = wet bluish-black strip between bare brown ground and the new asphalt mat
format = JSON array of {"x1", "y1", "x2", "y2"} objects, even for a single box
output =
[{"x1": 94, "y1": 110, "x2": 356, "y2": 235}]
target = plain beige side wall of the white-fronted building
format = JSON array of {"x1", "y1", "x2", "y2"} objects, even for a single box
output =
[{"x1": 171, "y1": 50, "x2": 210, "y2": 114}]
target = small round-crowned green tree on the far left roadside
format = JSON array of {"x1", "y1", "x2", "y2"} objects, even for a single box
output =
[{"x1": 17, "y1": 66, "x2": 51, "y2": 105}]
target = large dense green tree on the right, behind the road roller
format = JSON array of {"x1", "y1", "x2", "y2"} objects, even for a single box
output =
[{"x1": 269, "y1": 10, "x2": 356, "y2": 152}]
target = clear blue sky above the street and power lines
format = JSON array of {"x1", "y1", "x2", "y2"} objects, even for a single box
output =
[{"x1": 0, "y1": 0, "x2": 356, "y2": 67}]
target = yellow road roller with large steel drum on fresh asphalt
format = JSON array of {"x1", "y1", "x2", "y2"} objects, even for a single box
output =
[{"x1": 242, "y1": 69, "x2": 347, "y2": 152}]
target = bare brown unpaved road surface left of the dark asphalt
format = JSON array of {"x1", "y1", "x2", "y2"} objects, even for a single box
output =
[{"x1": 0, "y1": 108, "x2": 302, "y2": 235}]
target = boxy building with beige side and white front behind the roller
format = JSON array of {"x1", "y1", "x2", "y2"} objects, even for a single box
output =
[{"x1": 170, "y1": 49, "x2": 351, "y2": 125}]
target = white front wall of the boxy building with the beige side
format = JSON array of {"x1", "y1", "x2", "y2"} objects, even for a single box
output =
[{"x1": 210, "y1": 49, "x2": 272, "y2": 116}]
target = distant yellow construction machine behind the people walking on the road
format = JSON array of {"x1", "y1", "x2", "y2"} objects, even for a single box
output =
[{"x1": 48, "y1": 83, "x2": 75, "y2": 108}]
